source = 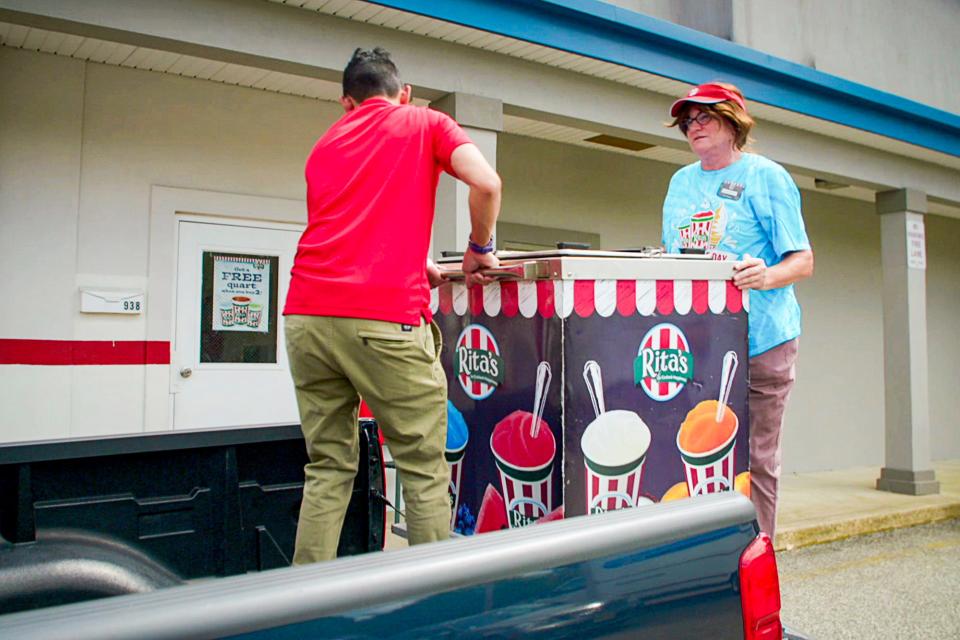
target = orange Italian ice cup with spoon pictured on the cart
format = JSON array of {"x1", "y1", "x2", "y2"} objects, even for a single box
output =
[{"x1": 677, "y1": 351, "x2": 740, "y2": 496}]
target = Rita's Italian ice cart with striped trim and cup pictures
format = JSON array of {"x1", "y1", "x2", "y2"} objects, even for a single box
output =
[{"x1": 431, "y1": 250, "x2": 749, "y2": 535}]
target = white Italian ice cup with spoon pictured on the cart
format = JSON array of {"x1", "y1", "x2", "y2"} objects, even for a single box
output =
[{"x1": 580, "y1": 360, "x2": 650, "y2": 513}]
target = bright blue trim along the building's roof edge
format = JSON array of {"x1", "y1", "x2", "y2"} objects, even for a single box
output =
[{"x1": 368, "y1": 0, "x2": 960, "y2": 157}]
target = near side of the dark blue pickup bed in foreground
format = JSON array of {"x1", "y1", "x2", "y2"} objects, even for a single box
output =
[{"x1": 0, "y1": 493, "x2": 764, "y2": 640}]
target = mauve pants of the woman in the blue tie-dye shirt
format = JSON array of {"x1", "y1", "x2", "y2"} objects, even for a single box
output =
[{"x1": 750, "y1": 338, "x2": 799, "y2": 538}]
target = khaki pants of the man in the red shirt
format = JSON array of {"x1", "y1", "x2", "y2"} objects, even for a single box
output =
[{"x1": 286, "y1": 315, "x2": 450, "y2": 564}]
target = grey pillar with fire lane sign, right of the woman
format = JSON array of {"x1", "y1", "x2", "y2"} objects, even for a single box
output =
[{"x1": 876, "y1": 189, "x2": 940, "y2": 495}]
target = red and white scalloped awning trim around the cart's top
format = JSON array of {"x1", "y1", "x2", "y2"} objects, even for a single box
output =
[{"x1": 430, "y1": 280, "x2": 750, "y2": 318}]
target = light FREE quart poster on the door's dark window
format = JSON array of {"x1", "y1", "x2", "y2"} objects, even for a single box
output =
[{"x1": 211, "y1": 255, "x2": 271, "y2": 333}]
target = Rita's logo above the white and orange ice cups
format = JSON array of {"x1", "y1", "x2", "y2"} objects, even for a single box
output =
[{"x1": 633, "y1": 322, "x2": 693, "y2": 402}]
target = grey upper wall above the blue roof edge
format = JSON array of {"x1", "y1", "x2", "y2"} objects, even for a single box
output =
[{"x1": 608, "y1": 0, "x2": 960, "y2": 113}]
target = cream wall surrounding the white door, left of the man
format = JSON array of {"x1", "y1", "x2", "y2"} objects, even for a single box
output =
[{"x1": 0, "y1": 48, "x2": 339, "y2": 440}]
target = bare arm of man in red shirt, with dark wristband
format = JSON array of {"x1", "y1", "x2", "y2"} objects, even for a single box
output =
[{"x1": 450, "y1": 144, "x2": 501, "y2": 284}]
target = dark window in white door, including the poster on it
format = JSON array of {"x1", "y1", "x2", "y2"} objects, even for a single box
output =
[{"x1": 199, "y1": 251, "x2": 280, "y2": 364}]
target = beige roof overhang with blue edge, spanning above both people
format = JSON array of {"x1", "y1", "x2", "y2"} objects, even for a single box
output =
[{"x1": 0, "y1": 0, "x2": 960, "y2": 218}]
